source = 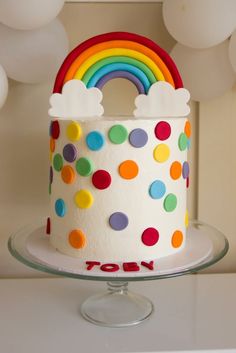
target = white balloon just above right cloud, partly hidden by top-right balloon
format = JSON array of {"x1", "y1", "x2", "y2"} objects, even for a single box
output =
[{"x1": 171, "y1": 40, "x2": 235, "y2": 101}]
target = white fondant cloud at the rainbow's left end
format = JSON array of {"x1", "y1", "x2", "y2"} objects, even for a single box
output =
[{"x1": 48, "y1": 80, "x2": 104, "y2": 121}]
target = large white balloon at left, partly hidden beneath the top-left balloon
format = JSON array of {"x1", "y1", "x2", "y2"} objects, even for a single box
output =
[{"x1": 0, "y1": 19, "x2": 68, "y2": 83}]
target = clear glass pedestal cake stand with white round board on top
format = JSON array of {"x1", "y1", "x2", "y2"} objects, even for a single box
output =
[{"x1": 8, "y1": 221, "x2": 229, "y2": 327}]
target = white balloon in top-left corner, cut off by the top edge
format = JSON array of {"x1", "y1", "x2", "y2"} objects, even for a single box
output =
[{"x1": 0, "y1": 0, "x2": 64, "y2": 29}]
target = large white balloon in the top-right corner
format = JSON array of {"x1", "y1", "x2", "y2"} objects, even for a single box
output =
[{"x1": 163, "y1": 0, "x2": 236, "y2": 49}]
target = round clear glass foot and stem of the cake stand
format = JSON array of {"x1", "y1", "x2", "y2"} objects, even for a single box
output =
[{"x1": 80, "y1": 281, "x2": 154, "y2": 327}]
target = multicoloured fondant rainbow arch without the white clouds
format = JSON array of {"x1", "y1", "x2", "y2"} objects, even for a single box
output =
[{"x1": 53, "y1": 32, "x2": 183, "y2": 94}]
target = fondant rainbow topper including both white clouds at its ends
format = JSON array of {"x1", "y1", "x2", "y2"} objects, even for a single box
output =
[{"x1": 49, "y1": 32, "x2": 190, "y2": 120}]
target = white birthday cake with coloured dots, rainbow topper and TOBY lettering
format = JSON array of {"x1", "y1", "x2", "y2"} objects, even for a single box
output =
[{"x1": 47, "y1": 32, "x2": 191, "y2": 271}]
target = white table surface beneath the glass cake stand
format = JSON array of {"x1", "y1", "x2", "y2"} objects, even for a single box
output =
[{"x1": 0, "y1": 274, "x2": 236, "y2": 353}]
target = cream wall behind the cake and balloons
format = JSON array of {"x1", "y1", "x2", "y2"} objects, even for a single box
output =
[{"x1": 0, "y1": 3, "x2": 236, "y2": 277}]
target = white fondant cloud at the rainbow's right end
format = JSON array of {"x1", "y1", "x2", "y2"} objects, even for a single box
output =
[{"x1": 134, "y1": 81, "x2": 190, "y2": 118}]
